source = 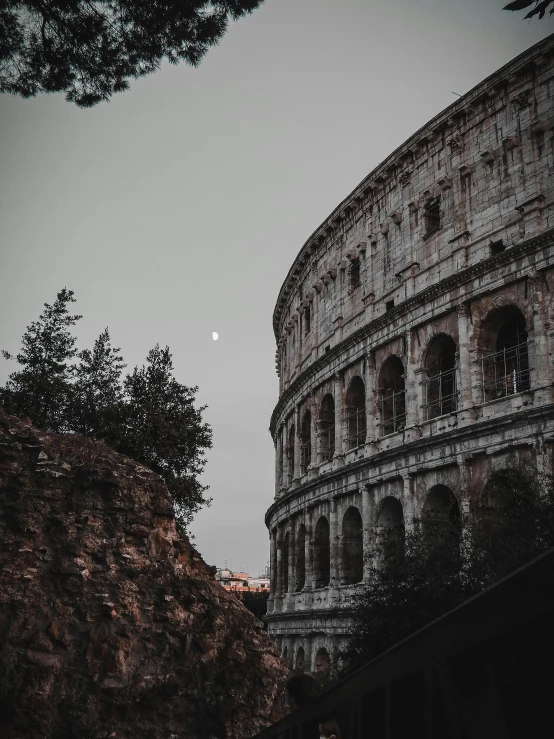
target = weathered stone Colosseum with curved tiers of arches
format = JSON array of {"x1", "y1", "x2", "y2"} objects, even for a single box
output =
[{"x1": 266, "y1": 36, "x2": 554, "y2": 672}]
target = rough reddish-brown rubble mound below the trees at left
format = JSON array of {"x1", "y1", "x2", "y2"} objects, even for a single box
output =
[{"x1": 0, "y1": 410, "x2": 286, "y2": 739}]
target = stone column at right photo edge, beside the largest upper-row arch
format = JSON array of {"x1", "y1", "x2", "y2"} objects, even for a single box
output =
[{"x1": 529, "y1": 273, "x2": 554, "y2": 405}]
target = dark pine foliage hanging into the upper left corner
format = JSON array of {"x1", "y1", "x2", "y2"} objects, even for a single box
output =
[{"x1": 0, "y1": 0, "x2": 263, "y2": 108}]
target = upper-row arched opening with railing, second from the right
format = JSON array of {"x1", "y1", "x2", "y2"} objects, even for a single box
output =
[{"x1": 425, "y1": 334, "x2": 456, "y2": 420}]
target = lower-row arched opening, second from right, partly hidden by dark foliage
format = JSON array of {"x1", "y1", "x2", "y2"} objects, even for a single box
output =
[{"x1": 422, "y1": 485, "x2": 462, "y2": 566}]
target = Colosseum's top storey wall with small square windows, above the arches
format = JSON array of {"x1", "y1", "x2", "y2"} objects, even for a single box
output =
[{"x1": 273, "y1": 38, "x2": 554, "y2": 393}]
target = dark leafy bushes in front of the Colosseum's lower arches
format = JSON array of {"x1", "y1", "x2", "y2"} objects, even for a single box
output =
[{"x1": 338, "y1": 468, "x2": 554, "y2": 677}]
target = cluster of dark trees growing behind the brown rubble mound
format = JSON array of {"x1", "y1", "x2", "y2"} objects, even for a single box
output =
[{"x1": 0, "y1": 288, "x2": 212, "y2": 531}]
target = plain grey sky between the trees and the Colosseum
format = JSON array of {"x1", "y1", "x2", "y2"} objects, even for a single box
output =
[{"x1": 0, "y1": 0, "x2": 554, "y2": 574}]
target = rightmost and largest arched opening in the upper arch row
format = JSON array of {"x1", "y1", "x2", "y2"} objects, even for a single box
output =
[{"x1": 480, "y1": 305, "x2": 530, "y2": 402}]
